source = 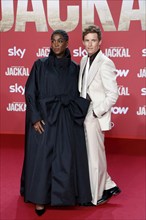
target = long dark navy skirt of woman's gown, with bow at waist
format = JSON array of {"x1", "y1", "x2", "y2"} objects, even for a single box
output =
[{"x1": 20, "y1": 95, "x2": 91, "y2": 206}]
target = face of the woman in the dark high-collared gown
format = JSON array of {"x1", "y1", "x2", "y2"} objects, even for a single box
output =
[{"x1": 51, "y1": 34, "x2": 68, "y2": 58}]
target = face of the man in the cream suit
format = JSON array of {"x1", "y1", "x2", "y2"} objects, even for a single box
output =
[{"x1": 83, "y1": 33, "x2": 101, "y2": 56}]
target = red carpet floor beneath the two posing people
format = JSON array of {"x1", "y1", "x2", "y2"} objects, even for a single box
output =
[{"x1": 0, "y1": 135, "x2": 146, "y2": 220}]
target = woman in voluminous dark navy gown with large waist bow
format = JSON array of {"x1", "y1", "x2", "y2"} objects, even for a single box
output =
[{"x1": 20, "y1": 30, "x2": 92, "y2": 215}]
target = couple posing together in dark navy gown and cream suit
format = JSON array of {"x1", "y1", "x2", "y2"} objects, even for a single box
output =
[{"x1": 20, "y1": 25, "x2": 121, "y2": 215}]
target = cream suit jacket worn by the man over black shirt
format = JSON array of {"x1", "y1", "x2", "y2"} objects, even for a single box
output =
[{"x1": 79, "y1": 50, "x2": 118, "y2": 131}]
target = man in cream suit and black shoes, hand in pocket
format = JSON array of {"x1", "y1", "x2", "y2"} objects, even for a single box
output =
[{"x1": 79, "y1": 25, "x2": 121, "y2": 205}]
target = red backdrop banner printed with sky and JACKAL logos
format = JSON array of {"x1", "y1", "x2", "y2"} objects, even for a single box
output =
[{"x1": 0, "y1": 0, "x2": 146, "y2": 139}]
